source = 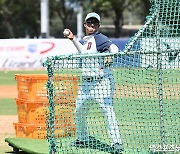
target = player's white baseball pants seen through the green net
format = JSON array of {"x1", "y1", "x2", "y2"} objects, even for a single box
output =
[{"x1": 75, "y1": 75, "x2": 122, "y2": 144}]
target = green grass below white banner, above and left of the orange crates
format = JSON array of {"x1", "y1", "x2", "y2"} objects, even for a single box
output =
[{"x1": 0, "y1": 70, "x2": 46, "y2": 85}]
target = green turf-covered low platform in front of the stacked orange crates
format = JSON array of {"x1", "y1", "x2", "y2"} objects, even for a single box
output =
[{"x1": 5, "y1": 138, "x2": 49, "y2": 154}]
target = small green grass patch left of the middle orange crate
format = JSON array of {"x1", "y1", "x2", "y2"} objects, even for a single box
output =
[{"x1": 0, "y1": 98, "x2": 17, "y2": 115}]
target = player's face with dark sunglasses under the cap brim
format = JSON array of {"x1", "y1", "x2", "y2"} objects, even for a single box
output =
[{"x1": 84, "y1": 18, "x2": 100, "y2": 35}]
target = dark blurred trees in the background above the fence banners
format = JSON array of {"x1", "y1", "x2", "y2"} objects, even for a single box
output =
[{"x1": 0, "y1": 0, "x2": 150, "y2": 39}]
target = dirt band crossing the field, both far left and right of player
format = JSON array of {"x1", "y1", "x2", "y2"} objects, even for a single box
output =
[{"x1": 0, "y1": 84, "x2": 180, "y2": 99}]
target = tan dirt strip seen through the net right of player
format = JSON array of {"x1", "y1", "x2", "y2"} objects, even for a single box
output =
[{"x1": 114, "y1": 84, "x2": 180, "y2": 100}]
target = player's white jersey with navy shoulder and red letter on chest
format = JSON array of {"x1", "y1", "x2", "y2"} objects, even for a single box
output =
[{"x1": 72, "y1": 32, "x2": 119, "y2": 77}]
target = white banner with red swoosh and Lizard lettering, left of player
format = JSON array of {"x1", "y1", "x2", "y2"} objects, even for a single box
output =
[{"x1": 0, "y1": 39, "x2": 78, "y2": 70}]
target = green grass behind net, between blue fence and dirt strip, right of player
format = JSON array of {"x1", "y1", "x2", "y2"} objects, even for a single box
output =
[{"x1": 114, "y1": 68, "x2": 180, "y2": 84}]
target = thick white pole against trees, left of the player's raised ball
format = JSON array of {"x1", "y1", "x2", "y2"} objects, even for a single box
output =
[{"x1": 41, "y1": 0, "x2": 49, "y2": 38}]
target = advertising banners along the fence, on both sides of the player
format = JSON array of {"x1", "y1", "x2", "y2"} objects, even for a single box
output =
[{"x1": 0, "y1": 38, "x2": 180, "y2": 70}]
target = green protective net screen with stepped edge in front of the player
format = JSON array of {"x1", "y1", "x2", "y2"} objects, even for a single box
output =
[{"x1": 45, "y1": 0, "x2": 180, "y2": 154}]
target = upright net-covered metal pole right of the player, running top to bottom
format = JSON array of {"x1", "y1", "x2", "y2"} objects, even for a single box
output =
[{"x1": 155, "y1": 0, "x2": 165, "y2": 150}]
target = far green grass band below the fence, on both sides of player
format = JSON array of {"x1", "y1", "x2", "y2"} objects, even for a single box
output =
[{"x1": 0, "y1": 68, "x2": 180, "y2": 85}]
